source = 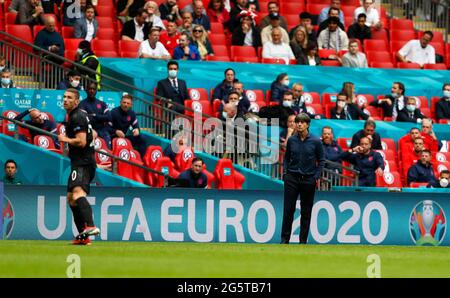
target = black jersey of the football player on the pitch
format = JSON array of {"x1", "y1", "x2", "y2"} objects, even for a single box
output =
[{"x1": 66, "y1": 107, "x2": 96, "y2": 166}]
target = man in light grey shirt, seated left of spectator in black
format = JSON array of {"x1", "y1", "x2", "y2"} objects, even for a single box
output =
[{"x1": 317, "y1": 17, "x2": 348, "y2": 52}]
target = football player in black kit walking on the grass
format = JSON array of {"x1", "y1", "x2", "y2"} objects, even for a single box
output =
[{"x1": 58, "y1": 88, "x2": 100, "y2": 245}]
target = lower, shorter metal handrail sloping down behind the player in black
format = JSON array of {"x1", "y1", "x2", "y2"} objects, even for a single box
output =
[{"x1": 0, "y1": 115, "x2": 169, "y2": 185}]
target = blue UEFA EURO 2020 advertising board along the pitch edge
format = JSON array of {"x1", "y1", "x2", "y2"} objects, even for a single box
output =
[{"x1": 0, "y1": 186, "x2": 450, "y2": 245}]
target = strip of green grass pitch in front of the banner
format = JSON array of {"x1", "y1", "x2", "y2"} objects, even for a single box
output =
[{"x1": 0, "y1": 240, "x2": 450, "y2": 278}]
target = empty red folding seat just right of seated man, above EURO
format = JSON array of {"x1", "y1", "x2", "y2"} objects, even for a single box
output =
[{"x1": 214, "y1": 158, "x2": 245, "y2": 189}]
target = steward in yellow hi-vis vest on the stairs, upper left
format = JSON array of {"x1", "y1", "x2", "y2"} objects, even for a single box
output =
[{"x1": 75, "y1": 40, "x2": 102, "y2": 90}]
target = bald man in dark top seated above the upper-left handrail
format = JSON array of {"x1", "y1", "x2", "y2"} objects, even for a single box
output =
[{"x1": 34, "y1": 15, "x2": 64, "y2": 64}]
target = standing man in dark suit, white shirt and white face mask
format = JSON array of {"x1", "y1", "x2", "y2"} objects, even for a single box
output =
[{"x1": 156, "y1": 60, "x2": 189, "y2": 114}]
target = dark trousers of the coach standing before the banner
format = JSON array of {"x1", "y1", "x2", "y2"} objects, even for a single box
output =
[{"x1": 281, "y1": 172, "x2": 316, "y2": 243}]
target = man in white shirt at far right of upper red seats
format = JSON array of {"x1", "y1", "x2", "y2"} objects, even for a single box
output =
[{"x1": 397, "y1": 31, "x2": 436, "y2": 68}]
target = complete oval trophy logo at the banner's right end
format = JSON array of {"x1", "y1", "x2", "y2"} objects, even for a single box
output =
[{"x1": 409, "y1": 200, "x2": 447, "y2": 246}]
